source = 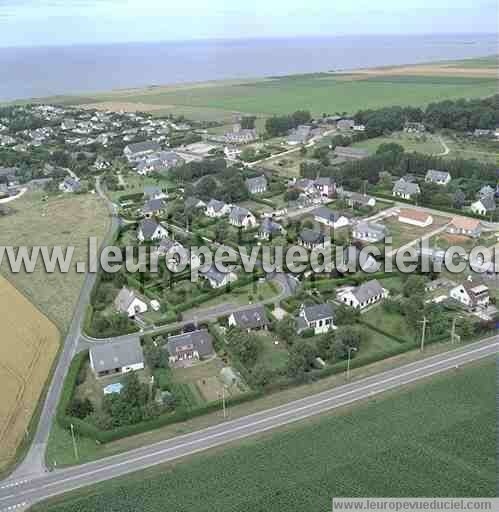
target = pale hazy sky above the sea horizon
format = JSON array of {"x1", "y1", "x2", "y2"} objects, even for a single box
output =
[{"x1": 0, "y1": 0, "x2": 498, "y2": 47}]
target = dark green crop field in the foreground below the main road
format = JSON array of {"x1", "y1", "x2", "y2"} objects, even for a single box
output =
[{"x1": 33, "y1": 359, "x2": 496, "y2": 512}]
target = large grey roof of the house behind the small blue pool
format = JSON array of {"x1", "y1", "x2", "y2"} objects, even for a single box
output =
[{"x1": 90, "y1": 336, "x2": 144, "y2": 372}]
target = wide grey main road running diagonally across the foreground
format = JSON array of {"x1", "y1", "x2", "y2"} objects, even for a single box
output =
[{"x1": 0, "y1": 336, "x2": 499, "y2": 510}]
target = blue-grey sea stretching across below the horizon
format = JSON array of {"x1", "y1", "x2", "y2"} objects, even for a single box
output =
[{"x1": 0, "y1": 34, "x2": 497, "y2": 101}]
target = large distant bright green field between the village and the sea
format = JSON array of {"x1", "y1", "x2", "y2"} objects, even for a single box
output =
[{"x1": 72, "y1": 73, "x2": 496, "y2": 115}]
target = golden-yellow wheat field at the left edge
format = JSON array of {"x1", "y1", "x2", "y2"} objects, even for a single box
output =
[{"x1": 0, "y1": 277, "x2": 59, "y2": 471}]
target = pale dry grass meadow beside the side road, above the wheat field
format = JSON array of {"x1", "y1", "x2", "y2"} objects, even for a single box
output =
[{"x1": 0, "y1": 193, "x2": 109, "y2": 333}]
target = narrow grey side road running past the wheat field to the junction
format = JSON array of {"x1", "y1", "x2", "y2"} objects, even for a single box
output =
[{"x1": 9, "y1": 179, "x2": 120, "y2": 480}]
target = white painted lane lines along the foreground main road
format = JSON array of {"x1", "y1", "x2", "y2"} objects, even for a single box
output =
[{"x1": 0, "y1": 341, "x2": 499, "y2": 501}]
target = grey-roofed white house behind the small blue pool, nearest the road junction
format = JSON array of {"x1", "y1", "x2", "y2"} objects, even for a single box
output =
[{"x1": 89, "y1": 336, "x2": 144, "y2": 377}]
